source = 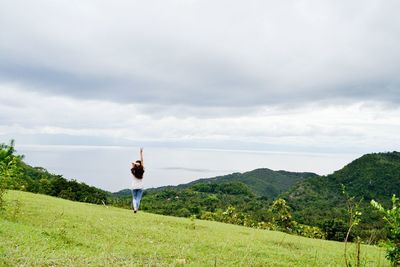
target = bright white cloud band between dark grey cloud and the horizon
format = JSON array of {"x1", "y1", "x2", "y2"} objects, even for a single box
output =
[{"x1": 0, "y1": 85, "x2": 400, "y2": 154}]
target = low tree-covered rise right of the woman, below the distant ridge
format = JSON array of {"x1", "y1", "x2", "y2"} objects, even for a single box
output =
[{"x1": 135, "y1": 182, "x2": 269, "y2": 222}]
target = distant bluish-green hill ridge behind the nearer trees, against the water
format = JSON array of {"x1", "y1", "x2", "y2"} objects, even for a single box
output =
[{"x1": 115, "y1": 168, "x2": 318, "y2": 199}]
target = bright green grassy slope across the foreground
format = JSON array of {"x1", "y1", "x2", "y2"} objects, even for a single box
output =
[{"x1": 0, "y1": 191, "x2": 389, "y2": 266}]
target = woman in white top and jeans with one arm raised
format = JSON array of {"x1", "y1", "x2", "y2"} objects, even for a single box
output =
[{"x1": 131, "y1": 148, "x2": 144, "y2": 213}]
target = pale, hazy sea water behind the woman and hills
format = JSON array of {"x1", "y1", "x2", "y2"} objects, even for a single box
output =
[{"x1": 17, "y1": 146, "x2": 359, "y2": 192}]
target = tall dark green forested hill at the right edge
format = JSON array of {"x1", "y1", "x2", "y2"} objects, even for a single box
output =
[{"x1": 281, "y1": 152, "x2": 400, "y2": 230}]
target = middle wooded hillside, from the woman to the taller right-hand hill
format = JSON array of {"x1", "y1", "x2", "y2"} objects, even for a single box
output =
[{"x1": 113, "y1": 168, "x2": 316, "y2": 228}]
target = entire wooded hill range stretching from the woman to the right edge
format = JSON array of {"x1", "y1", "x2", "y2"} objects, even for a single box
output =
[{"x1": 111, "y1": 152, "x2": 400, "y2": 242}]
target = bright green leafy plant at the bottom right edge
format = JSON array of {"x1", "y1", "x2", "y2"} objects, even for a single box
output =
[{"x1": 371, "y1": 195, "x2": 400, "y2": 266}]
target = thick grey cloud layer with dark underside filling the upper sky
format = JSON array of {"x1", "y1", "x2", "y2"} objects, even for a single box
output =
[{"x1": 0, "y1": 0, "x2": 400, "y2": 107}]
